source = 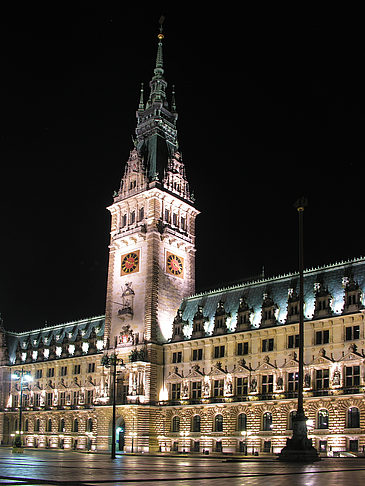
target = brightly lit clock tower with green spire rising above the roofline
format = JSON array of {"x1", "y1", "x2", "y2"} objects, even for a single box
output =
[{"x1": 105, "y1": 27, "x2": 199, "y2": 370}]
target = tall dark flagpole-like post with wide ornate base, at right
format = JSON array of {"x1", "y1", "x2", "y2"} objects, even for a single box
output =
[{"x1": 279, "y1": 198, "x2": 319, "y2": 462}]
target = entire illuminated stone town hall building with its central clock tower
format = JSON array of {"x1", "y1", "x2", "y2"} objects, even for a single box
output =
[{"x1": 0, "y1": 27, "x2": 365, "y2": 453}]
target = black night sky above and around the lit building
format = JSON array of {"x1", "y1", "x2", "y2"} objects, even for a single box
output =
[{"x1": 0, "y1": 1, "x2": 365, "y2": 330}]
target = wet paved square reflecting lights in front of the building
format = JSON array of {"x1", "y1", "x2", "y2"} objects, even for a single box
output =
[{"x1": 0, "y1": 449, "x2": 365, "y2": 486}]
